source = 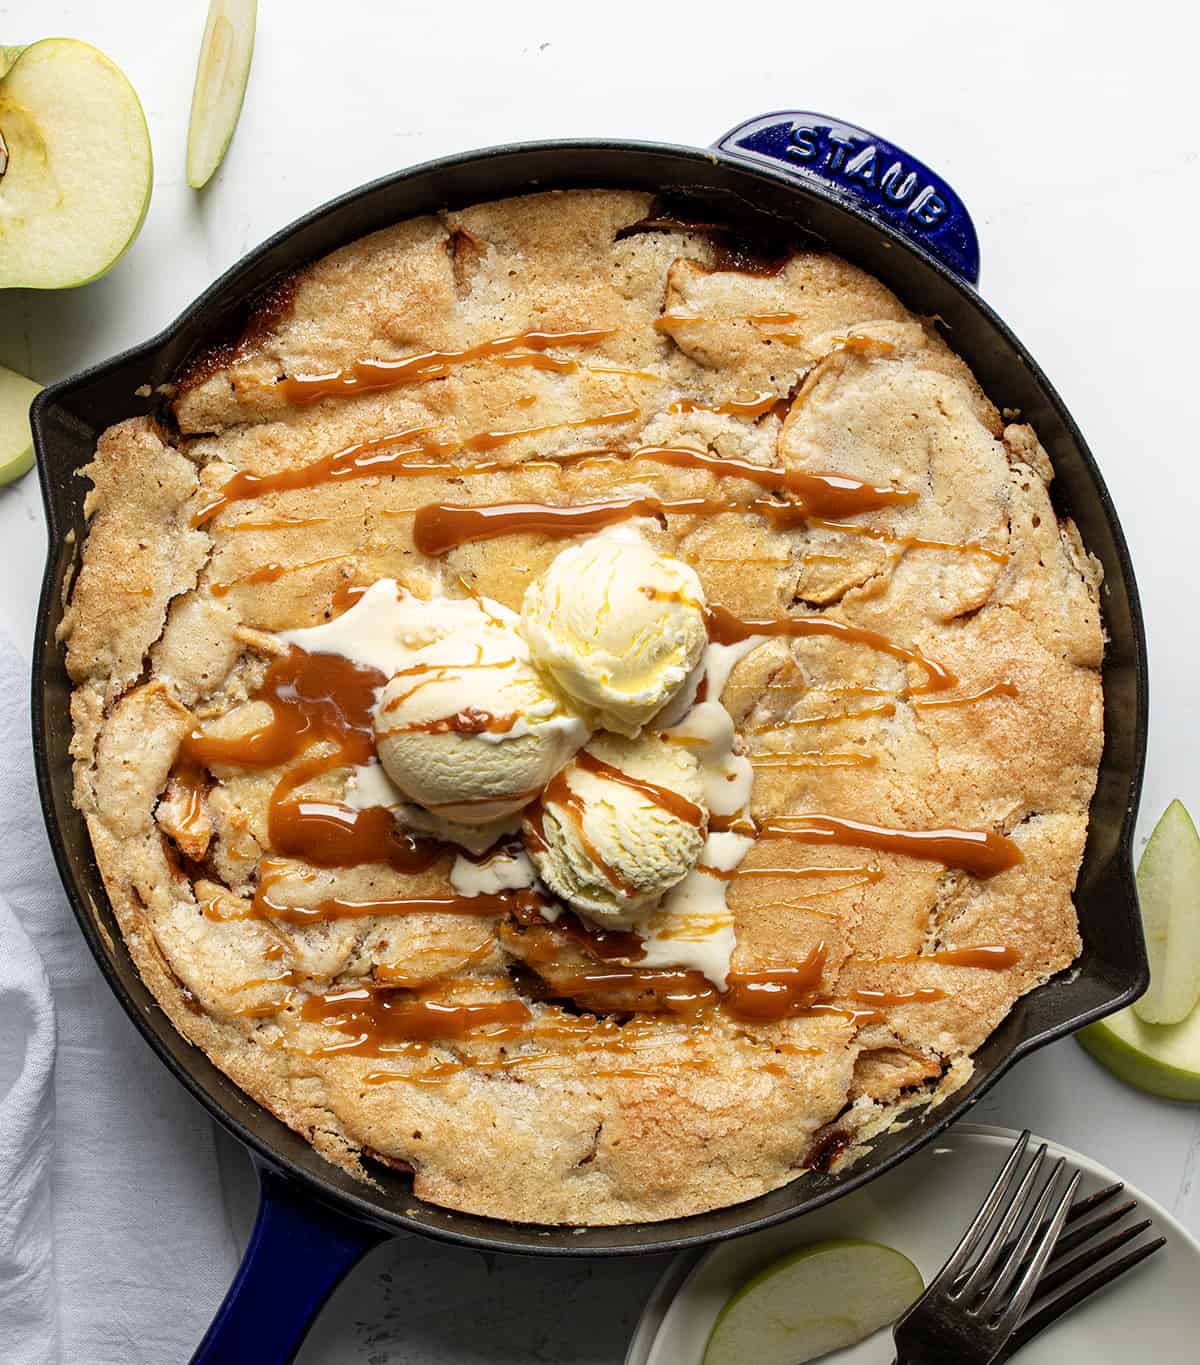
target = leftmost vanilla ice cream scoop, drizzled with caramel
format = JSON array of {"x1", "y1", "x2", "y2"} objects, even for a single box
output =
[{"x1": 375, "y1": 603, "x2": 588, "y2": 826}]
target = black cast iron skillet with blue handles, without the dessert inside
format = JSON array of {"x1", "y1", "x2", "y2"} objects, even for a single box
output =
[{"x1": 33, "y1": 113, "x2": 1147, "y2": 1365}]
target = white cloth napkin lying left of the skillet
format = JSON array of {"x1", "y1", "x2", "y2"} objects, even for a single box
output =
[{"x1": 0, "y1": 640, "x2": 238, "y2": 1365}]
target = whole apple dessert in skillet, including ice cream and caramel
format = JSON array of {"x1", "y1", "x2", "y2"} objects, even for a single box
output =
[{"x1": 63, "y1": 190, "x2": 1103, "y2": 1224}]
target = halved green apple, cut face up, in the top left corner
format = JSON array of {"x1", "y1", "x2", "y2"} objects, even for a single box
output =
[{"x1": 0, "y1": 38, "x2": 153, "y2": 289}]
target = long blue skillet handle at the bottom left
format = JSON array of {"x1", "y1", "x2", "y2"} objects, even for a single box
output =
[{"x1": 191, "y1": 1162, "x2": 388, "y2": 1365}]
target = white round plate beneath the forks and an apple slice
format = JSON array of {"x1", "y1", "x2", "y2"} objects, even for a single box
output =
[{"x1": 625, "y1": 1123, "x2": 1200, "y2": 1365}]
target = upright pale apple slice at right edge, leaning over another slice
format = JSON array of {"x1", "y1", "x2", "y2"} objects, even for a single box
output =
[{"x1": 1133, "y1": 801, "x2": 1200, "y2": 1024}]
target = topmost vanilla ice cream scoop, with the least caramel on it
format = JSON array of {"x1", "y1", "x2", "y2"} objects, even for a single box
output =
[{"x1": 520, "y1": 527, "x2": 707, "y2": 737}]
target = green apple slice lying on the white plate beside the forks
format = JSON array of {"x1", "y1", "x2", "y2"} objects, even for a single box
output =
[{"x1": 704, "y1": 1241, "x2": 924, "y2": 1365}]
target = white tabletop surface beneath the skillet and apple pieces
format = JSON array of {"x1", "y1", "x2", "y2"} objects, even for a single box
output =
[{"x1": 0, "y1": 0, "x2": 1200, "y2": 1365}]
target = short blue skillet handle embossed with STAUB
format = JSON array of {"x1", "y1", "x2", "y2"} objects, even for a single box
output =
[{"x1": 714, "y1": 112, "x2": 979, "y2": 285}]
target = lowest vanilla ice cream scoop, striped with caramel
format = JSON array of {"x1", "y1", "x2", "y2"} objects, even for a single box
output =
[{"x1": 524, "y1": 734, "x2": 709, "y2": 928}]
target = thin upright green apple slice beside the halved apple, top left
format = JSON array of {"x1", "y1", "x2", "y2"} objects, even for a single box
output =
[{"x1": 187, "y1": 0, "x2": 258, "y2": 190}]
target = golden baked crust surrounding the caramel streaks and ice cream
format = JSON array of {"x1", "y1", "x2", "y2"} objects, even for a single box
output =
[{"x1": 63, "y1": 191, "x2": 1102, "y2": 1224}]
